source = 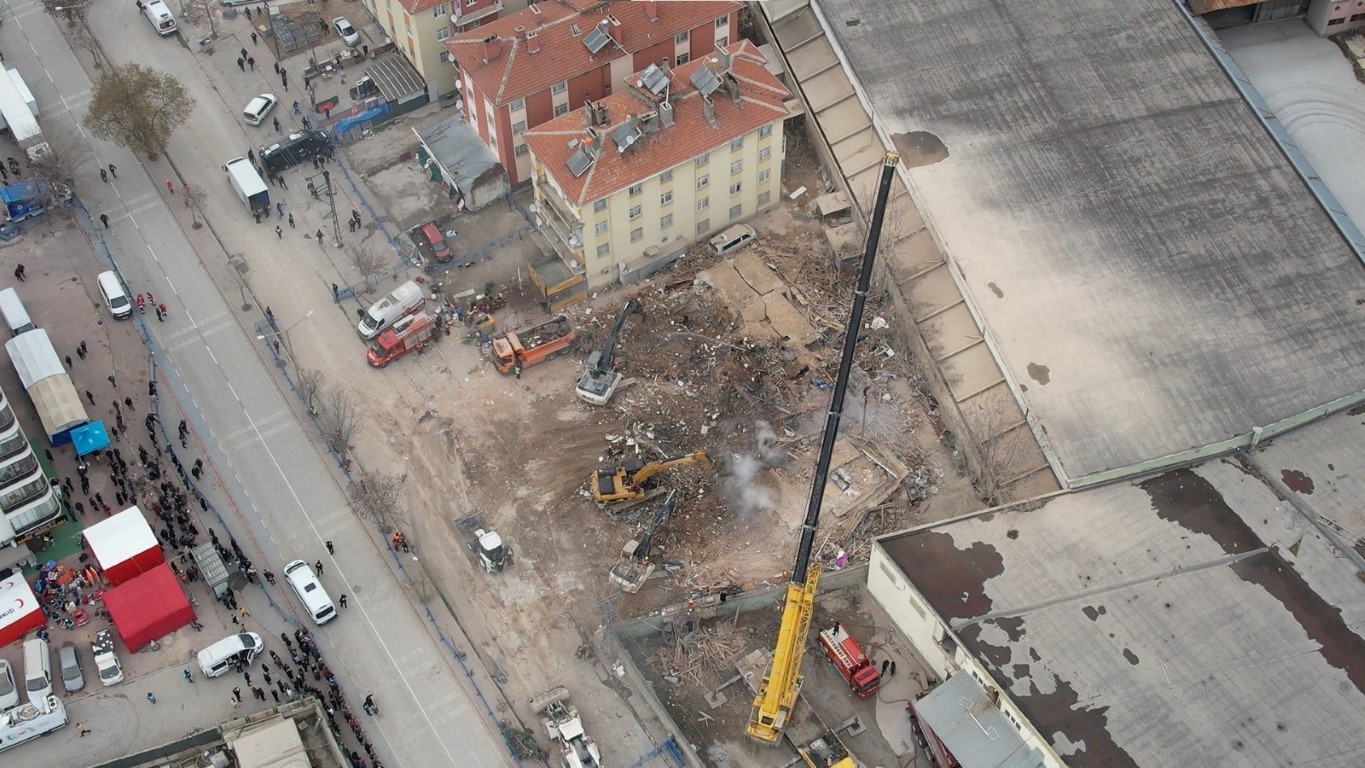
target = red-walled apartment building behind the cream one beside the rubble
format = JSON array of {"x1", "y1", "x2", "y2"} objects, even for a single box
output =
[{"x1": 445, "y1": 0, "x2": 741, "y2": 186}]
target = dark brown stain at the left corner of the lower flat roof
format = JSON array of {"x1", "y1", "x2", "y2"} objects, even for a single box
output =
[{"x1": 886, "y1": 531, "x2": 1005, "y2": 622}]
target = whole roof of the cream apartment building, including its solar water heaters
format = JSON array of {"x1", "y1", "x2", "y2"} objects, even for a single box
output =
[{"x1": 523, "y1": 41, "x2": 788, "y2": 206}]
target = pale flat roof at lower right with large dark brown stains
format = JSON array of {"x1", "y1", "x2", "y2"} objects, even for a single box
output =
[{"x1": 879, "y1": 444, "x2": 1365, "y2": 768}]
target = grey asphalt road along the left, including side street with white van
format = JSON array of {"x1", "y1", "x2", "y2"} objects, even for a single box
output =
[{"x1": 0, "y1": 0, "x2": 509, "y2": 768}]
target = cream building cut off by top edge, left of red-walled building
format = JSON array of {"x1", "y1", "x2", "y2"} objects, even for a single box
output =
[{"x1": 351, "y1": 0, "x2": 528, "y2": 98}]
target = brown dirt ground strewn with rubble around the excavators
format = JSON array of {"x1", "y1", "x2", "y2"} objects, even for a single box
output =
[{"x1": 313, "y1": 115, "x2": 988, "y2": 764}]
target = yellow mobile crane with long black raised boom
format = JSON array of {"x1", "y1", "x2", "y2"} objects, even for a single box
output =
[{"x1": 744, "y1": 151, "x2": 901, "y2": 768}]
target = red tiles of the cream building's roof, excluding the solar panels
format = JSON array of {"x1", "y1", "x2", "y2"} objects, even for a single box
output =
[{"x1": 523, "y1": 40, "x2": 789, "y2": 207}]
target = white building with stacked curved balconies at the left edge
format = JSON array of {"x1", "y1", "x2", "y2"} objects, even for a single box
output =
[{"x1": 0, "y1": 392, "x2": 63, "y2": 546}]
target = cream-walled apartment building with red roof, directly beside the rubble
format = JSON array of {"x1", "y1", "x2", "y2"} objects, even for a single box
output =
[{"x1": 524, "y1": 41, "x2": 789, "y2": 289}]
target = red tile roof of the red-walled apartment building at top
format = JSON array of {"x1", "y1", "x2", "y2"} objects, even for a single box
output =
[{"x1": 445, "y1": 0, "x2": 740, "y2": 106}]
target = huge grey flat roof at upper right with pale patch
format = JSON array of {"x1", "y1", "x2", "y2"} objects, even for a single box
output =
[{"x1": 818, "y1": 0, "x2": 1365, "y2": 480}]
